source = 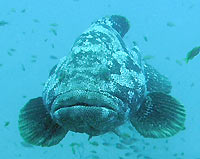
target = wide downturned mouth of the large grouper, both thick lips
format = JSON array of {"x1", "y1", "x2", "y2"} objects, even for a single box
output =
[{"x1": 51, "y1": 90, "x2": 125, "y2": 136}]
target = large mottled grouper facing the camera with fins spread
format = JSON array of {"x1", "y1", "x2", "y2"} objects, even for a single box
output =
[{"x1": 18, "y1": 15, "x2": 186, "y2": 147}]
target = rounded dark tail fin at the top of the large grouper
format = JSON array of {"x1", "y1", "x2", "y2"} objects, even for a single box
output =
[{"x1": 95, "y1": 15, "x2": 130, "y2": 37}]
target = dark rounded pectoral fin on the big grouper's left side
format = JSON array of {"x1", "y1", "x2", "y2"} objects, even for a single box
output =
[{"x1": 18, "y1": 97, "x2": 67, "y2": 147}]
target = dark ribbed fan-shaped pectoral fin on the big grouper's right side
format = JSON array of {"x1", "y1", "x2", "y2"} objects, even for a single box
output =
[{"x1": 131, "y1": 92, "x2": 186, "y2": 138}]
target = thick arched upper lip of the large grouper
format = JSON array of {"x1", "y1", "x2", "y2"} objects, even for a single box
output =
[{"x1": 52, "y1": 90, "x2": 121, "y2": 112}]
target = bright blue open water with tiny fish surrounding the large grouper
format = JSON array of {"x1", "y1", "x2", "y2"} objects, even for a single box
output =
[{"x1": 0, "y1": 0, "x2": 200, "y2": 159}]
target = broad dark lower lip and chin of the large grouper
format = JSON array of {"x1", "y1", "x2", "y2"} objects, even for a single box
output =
[{"x1": 51, "y1": 105, "x2": 121, "y2": 136}]
